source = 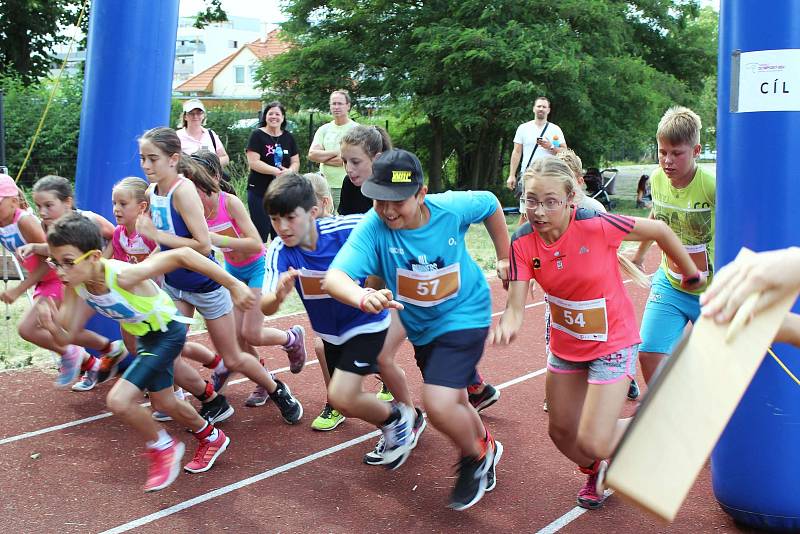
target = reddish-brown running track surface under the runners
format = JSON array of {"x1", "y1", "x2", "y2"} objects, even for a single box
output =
[{"x1": 0, "y1": 251, "x2": 752, "y2": 533}]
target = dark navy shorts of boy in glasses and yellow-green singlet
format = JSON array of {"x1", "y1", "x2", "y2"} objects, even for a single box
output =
[{"x1": 122, "y1": 321, "x2": 186, "y2": 392}]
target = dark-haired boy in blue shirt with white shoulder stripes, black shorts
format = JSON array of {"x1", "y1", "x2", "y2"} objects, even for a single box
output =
[{"x1": 261, "y1": 173, "x2": 418, "y2": 469}]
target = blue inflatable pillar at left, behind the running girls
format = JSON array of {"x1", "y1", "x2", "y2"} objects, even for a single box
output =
[{"x1": 75, "y1": 0, "x2": 179, "y2": 354}]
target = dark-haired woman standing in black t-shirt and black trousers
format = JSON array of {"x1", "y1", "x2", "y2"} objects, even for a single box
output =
[{"x1": 246, "y1": 101, "x2": 300, "y2": 243}]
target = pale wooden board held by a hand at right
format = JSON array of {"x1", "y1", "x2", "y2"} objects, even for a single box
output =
[{"x1": 606, "y1": 249, "x2": 797, "y2": 521}]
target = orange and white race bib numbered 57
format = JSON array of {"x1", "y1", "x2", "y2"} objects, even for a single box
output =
[{"x1": 396, "y1": 263, "x2": 461, "y2": 308}]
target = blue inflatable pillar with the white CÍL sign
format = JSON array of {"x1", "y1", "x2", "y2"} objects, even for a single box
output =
[{"x1": 711, "y1": 0, "x2": 800, "y2": 532}]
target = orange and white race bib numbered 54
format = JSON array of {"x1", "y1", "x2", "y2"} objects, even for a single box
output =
[{"x1": 547, "y1": 295, "x2": 608, "y2": 341}]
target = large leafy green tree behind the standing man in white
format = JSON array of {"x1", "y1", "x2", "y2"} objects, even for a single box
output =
[{"x1": 258, "y1": 0, "x2": 716, "y2": 190}]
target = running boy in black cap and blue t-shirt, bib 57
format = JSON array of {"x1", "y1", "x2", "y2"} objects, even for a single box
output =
[{"x1": 325, "y1": 150, "x2": 510, "y2": 510}]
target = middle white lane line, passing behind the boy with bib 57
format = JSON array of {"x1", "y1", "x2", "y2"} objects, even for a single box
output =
[{"x1": 101, "y1": 369, "x2": 547, "y2": 534}]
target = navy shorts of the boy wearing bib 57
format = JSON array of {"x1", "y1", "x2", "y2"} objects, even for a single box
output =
[{"x1": 414, "y1": 327, "x2": 489, "y2": 389}]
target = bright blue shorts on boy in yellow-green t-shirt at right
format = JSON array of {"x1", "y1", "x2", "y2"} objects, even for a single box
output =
[{"x1": 639, "y1": 268, "x2": 700, "y2": 354}]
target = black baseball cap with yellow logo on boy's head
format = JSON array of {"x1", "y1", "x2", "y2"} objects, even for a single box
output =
[{"x1": 361, "y1": 148, "x2": 425, "y2": 202}]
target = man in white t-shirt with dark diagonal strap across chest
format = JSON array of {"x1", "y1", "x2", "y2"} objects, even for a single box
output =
[{"x1": 506, "y1": 96, "x2": 567, "y2": 195}]
